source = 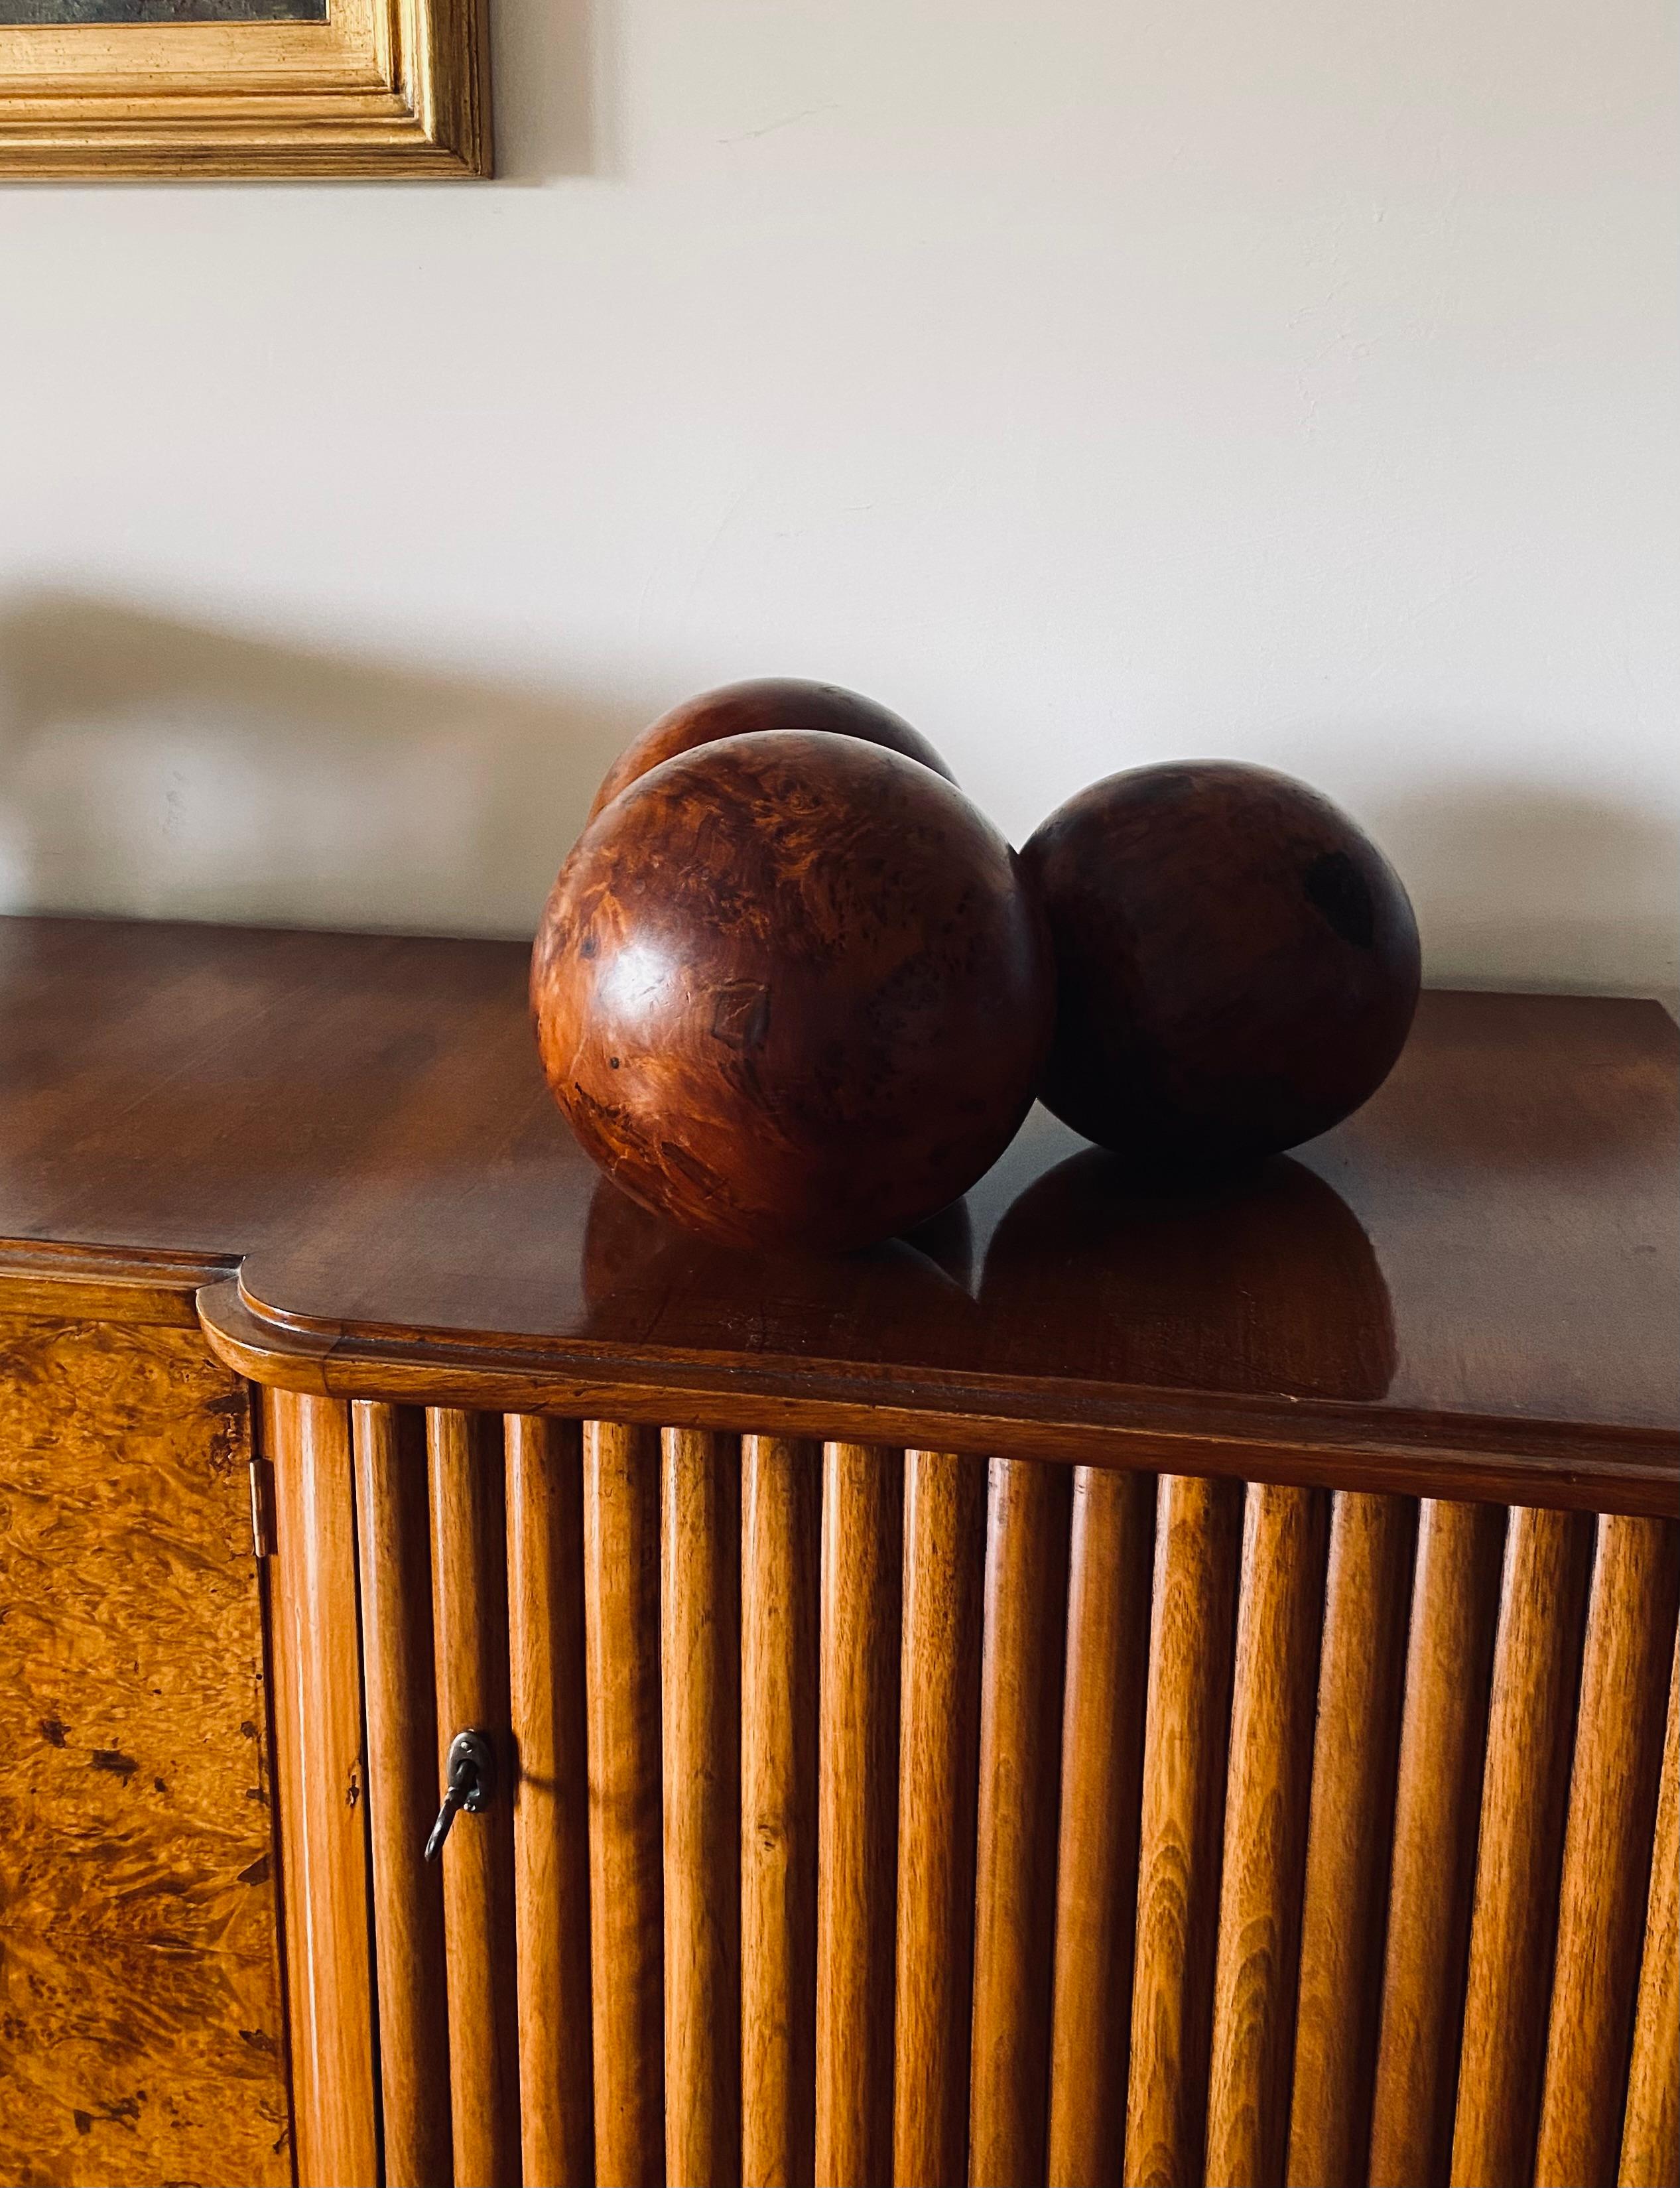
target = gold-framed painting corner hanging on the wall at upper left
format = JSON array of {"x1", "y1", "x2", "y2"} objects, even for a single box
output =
[{"x1": 0, "y1": 0, "x2": 490, "y2": 180}]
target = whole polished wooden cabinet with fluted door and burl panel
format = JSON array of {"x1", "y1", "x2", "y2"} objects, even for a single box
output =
[{"x1": 0, "y1": 921, "x2": 1680, "y2": 2188}]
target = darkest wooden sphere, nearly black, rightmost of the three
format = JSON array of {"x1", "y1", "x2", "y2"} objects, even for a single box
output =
[{"x1": 1021, "y1": 761, "x2": 1417, "y2": 1166}]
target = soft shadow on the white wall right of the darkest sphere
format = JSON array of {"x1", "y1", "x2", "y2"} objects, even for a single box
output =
[{"x1": 1370, "y1": 781, "x2": 1680, "y2": 1015}]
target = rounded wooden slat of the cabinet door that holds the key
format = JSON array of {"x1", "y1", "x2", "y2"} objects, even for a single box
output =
[{"x1": 426, "y1": 1407, "x2": 521, "y2": 2188}]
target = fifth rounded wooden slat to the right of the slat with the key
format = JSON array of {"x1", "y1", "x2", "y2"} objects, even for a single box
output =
[{"x1": 816, "y1": 1444, "x2": 903, "y2": 2188}]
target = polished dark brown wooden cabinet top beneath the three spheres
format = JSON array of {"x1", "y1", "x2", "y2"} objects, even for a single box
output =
[{"x1": 0, "y1": 919, "x2": 1680, "y2": 1510}]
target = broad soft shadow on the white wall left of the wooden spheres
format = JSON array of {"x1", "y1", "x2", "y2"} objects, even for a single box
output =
[{"x1": 0, "y1": 595, "x2": 641, "y2": 934}]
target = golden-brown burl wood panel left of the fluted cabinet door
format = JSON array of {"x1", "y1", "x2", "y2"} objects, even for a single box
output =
[{"x1": 0, "y1": 1317, "x2": 291, "y2": 2188}]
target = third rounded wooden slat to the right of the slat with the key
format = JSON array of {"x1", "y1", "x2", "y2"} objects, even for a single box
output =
[{"x1": 661, "y1": 1429, "x2": 742, "y2": 2188}]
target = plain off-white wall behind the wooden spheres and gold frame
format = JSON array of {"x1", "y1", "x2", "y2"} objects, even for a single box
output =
[{"x1": 0, "y1": 0, "x2": 1680, "y2": 991}]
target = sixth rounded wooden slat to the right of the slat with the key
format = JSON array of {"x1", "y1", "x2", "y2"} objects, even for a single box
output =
[{"x1": 893, "y1": 1450, "x2": 986, "y2": 2188}]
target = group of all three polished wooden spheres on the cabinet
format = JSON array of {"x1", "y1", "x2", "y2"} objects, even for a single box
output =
[{"x1": 531, "y1": 680, "x2": 1417, "y2": 1252}]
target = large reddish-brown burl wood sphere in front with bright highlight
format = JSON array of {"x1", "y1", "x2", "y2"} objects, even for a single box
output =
[{"x1": 531, "y1": 731, "x2": 1052, "y2": 1252}]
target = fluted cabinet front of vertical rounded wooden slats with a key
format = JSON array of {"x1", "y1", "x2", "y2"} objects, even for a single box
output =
[{"x1": 265, "y1": 1398, "x2": 1680, "y2": 2188}]
